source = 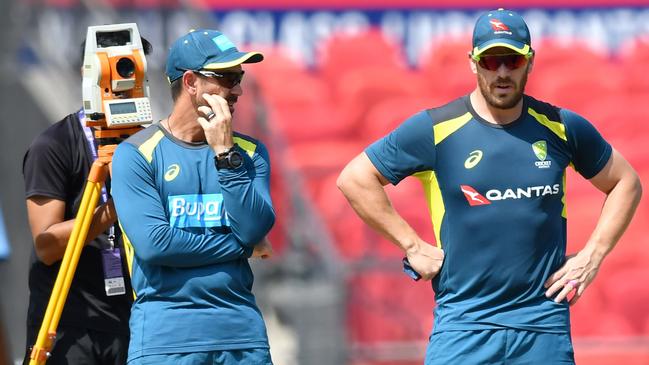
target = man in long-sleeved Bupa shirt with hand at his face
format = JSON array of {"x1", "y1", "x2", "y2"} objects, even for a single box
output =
[{"x1": 112, "y1": 30, "x2": 275, "y2": 365}]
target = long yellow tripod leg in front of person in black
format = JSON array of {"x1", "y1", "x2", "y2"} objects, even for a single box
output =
[{"x1": 29, "y1": 161, "x2": 106, "y2": 365}]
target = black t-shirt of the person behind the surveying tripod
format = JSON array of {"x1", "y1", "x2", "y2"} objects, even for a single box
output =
[{"x1": 23, "y1": 113, "x2": 133, "y2": 335}]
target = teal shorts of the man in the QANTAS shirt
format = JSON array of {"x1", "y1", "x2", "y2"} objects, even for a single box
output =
[{"x1": 425, "y1": 329, "x2": 575, "y2": 365}]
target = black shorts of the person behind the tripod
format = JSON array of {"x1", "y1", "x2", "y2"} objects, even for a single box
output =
[{"x1": 23, "y1": 326, "x2": 129, "y2": 365}]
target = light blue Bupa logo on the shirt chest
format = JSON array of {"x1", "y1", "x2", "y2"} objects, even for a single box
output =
[{"x1": 168, "y1": 194, "x2": 230, "y2": 228}]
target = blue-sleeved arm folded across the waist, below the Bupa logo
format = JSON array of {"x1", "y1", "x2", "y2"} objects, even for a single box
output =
[{"x1": 111, "y1": 143, "x2": 252, "y2": 267}]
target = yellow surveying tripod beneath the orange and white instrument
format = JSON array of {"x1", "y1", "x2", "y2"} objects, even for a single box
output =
[{"x1": 29, "y1": 126, "x2": 142, "y2": 365}]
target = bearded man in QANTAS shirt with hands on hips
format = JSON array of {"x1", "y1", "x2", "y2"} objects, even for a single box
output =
[{"x1": 338, "y1": 9, "x2": 641, "y2": 365}]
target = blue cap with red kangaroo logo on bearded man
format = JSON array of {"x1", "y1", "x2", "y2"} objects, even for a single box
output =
[{"x1": 471, "y1": 8, "x2": 532, "y2": 57}]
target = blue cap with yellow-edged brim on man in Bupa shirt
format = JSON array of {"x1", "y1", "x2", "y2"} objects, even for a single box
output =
[{"x1": 165, "y1": 29, "x2": 264, "y2": 82}]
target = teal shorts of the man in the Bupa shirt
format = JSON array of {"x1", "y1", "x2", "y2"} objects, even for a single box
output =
[{"x1": 128, "y1": 349, "x2": 273, "y2": 365}]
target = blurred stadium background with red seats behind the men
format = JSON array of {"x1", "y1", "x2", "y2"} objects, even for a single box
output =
[{"x1": 0, "y1": 0, "x2": 649, "y2": 365}]
